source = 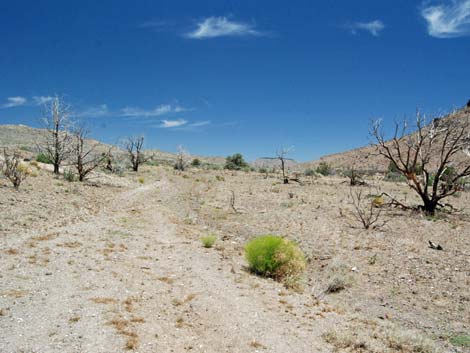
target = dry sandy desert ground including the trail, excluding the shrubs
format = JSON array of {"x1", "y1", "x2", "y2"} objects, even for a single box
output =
[{"x1": 0, "y1": 167, "x2": 470, "y2": 353}]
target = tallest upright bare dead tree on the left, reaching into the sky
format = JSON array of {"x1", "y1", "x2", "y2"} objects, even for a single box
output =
[{"x1": 40, "y1": 96, "x2": 71, "y2": 174}]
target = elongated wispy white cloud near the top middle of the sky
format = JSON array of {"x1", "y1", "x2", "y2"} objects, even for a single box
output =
[{"x1": 186, "y1": 17, "x2": 261, "y2": 39}]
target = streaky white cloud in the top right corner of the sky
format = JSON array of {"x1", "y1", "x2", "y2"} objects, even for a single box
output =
[{"x1": 421, "y1": 0, "x2": 470, "y2": 38}]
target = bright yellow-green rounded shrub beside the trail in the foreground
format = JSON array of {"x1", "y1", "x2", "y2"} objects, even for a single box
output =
[{"x1": 245, "y1": 235, "x2": 306, "y2": 283}]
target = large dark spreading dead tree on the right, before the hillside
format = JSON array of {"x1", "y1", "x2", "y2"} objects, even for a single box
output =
[{"x1": 371, "y1": 113, "x2": 470, "y2": 215}]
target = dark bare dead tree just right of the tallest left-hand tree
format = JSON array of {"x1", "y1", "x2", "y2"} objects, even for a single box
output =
[{"x1": 70, "y1": 126, "x2": 111, "y2": 181}]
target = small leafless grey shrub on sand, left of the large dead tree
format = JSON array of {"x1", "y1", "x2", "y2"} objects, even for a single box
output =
[{"x1": 349, "y1": 188, "x2": 385, "y2": 229}]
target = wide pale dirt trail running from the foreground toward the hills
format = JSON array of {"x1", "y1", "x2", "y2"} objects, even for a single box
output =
[{"x1": 0, "y1": 180, "x2": 336, "y2": 353}]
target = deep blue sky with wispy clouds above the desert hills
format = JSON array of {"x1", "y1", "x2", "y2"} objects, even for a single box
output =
[{"x1": 0, "y1": 0, "x2": 470, "y2": 160}]
